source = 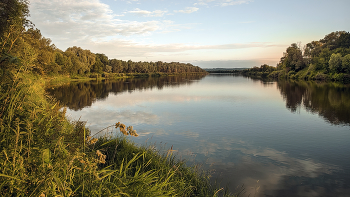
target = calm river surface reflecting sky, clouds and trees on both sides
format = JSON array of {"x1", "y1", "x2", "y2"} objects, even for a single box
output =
[{"x1": 48, "y1": 75, "x2": 350, "y2": 197}]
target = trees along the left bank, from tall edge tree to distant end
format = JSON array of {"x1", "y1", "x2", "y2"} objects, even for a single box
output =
[{"x1": 0, "y1": 0, "x2": 205, "y2": 75}]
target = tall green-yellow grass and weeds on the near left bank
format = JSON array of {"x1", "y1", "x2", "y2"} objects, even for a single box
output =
[{"x1": 0, "y1": 70, "x2": 235, "y2": 196}]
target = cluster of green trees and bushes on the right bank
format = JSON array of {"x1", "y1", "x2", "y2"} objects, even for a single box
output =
[{"x1": 244, "y1": 31, "x2": 350, "y2": 83}]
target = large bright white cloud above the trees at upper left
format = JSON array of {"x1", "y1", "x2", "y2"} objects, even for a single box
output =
[{"x1": 30, "y1": 0, "x2": 163, "y2": 40}]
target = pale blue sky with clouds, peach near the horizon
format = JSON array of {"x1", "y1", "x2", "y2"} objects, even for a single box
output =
[{"x1": 29, "y1": 0, "x2": 350, "y2": 68}]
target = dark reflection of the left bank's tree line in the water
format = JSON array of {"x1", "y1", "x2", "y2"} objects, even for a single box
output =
[{"x1": 46, "y1": 74, "x2": 205, "y2": 111}]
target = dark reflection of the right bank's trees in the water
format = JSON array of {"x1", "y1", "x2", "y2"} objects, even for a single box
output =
[{"x1": 277, "y1": 81, "x2": 350, "y2": 125}]
